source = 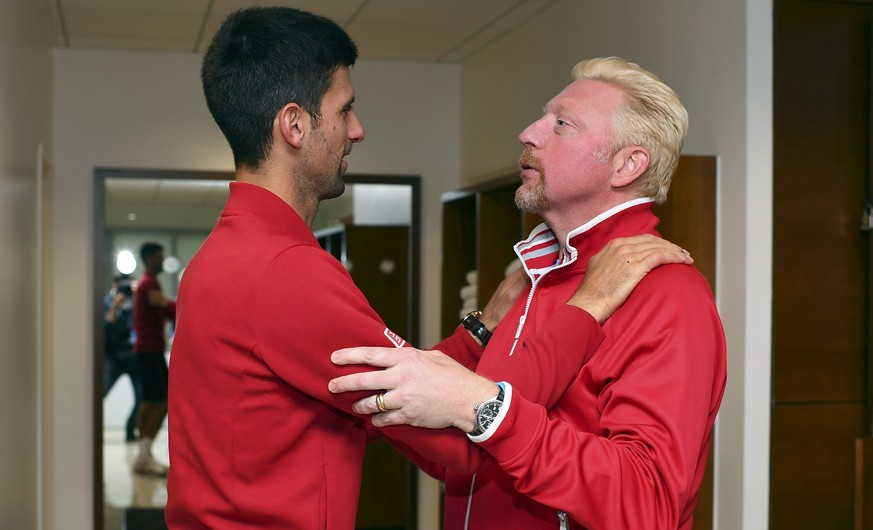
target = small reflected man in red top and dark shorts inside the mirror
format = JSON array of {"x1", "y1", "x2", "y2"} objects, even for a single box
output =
[{"x1": 133, "y1": 242, "x2": 176, "y2": 476}]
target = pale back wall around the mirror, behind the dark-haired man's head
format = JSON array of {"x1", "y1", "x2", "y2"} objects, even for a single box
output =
[{"x1": 49, "y1": 50, "x2": 460, "y2": 528}]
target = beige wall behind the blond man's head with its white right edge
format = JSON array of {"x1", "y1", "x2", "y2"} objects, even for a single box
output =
[{"x1": 461, "y1": 0, "x2": 772, "y2": 530}]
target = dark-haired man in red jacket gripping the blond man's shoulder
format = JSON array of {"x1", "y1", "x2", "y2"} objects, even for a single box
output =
[{"x1": 166, "y1": 8, "x2": 689, "y2": 530}]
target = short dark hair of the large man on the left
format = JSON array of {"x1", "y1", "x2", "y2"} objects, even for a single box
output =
[{"x1": 200, "y1": 7, "x2": 358, "y2": 169}]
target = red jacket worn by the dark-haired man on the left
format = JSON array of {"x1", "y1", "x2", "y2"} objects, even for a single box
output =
[{"x1": 166, "y1": 182, "x2": 603, "y2": 530}]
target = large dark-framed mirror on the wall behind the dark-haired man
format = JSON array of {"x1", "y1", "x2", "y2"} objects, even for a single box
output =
[{"x1": 93, "y1": 168, "x2": 421, "y2": 530}]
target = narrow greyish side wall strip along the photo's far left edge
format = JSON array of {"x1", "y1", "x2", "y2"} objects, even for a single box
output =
[{"x1": 0, "y1": 0, "x2": 52, "y2": 528}]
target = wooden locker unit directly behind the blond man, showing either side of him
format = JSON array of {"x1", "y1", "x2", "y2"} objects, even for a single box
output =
[{"x1": 442, "y1": 156, "x2": 716, "y2": 530}]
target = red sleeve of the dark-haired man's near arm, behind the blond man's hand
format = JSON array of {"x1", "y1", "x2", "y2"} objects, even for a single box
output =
[{"x1": 256, "y1": 248, "x2": 612, "y2": 475}]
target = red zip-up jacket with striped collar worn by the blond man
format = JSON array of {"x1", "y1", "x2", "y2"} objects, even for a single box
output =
[{"x1": 398, "y1": 199, "x2": 726, "y2": 530}]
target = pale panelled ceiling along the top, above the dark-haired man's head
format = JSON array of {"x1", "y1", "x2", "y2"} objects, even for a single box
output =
[{"x1": 43, "y1": 0, "x2": 558, "y2": 63}]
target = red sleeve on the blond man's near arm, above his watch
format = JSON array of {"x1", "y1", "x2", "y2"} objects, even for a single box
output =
[{"x1": 480, "y1": 267, "x2": 726, "y2": 530}]
